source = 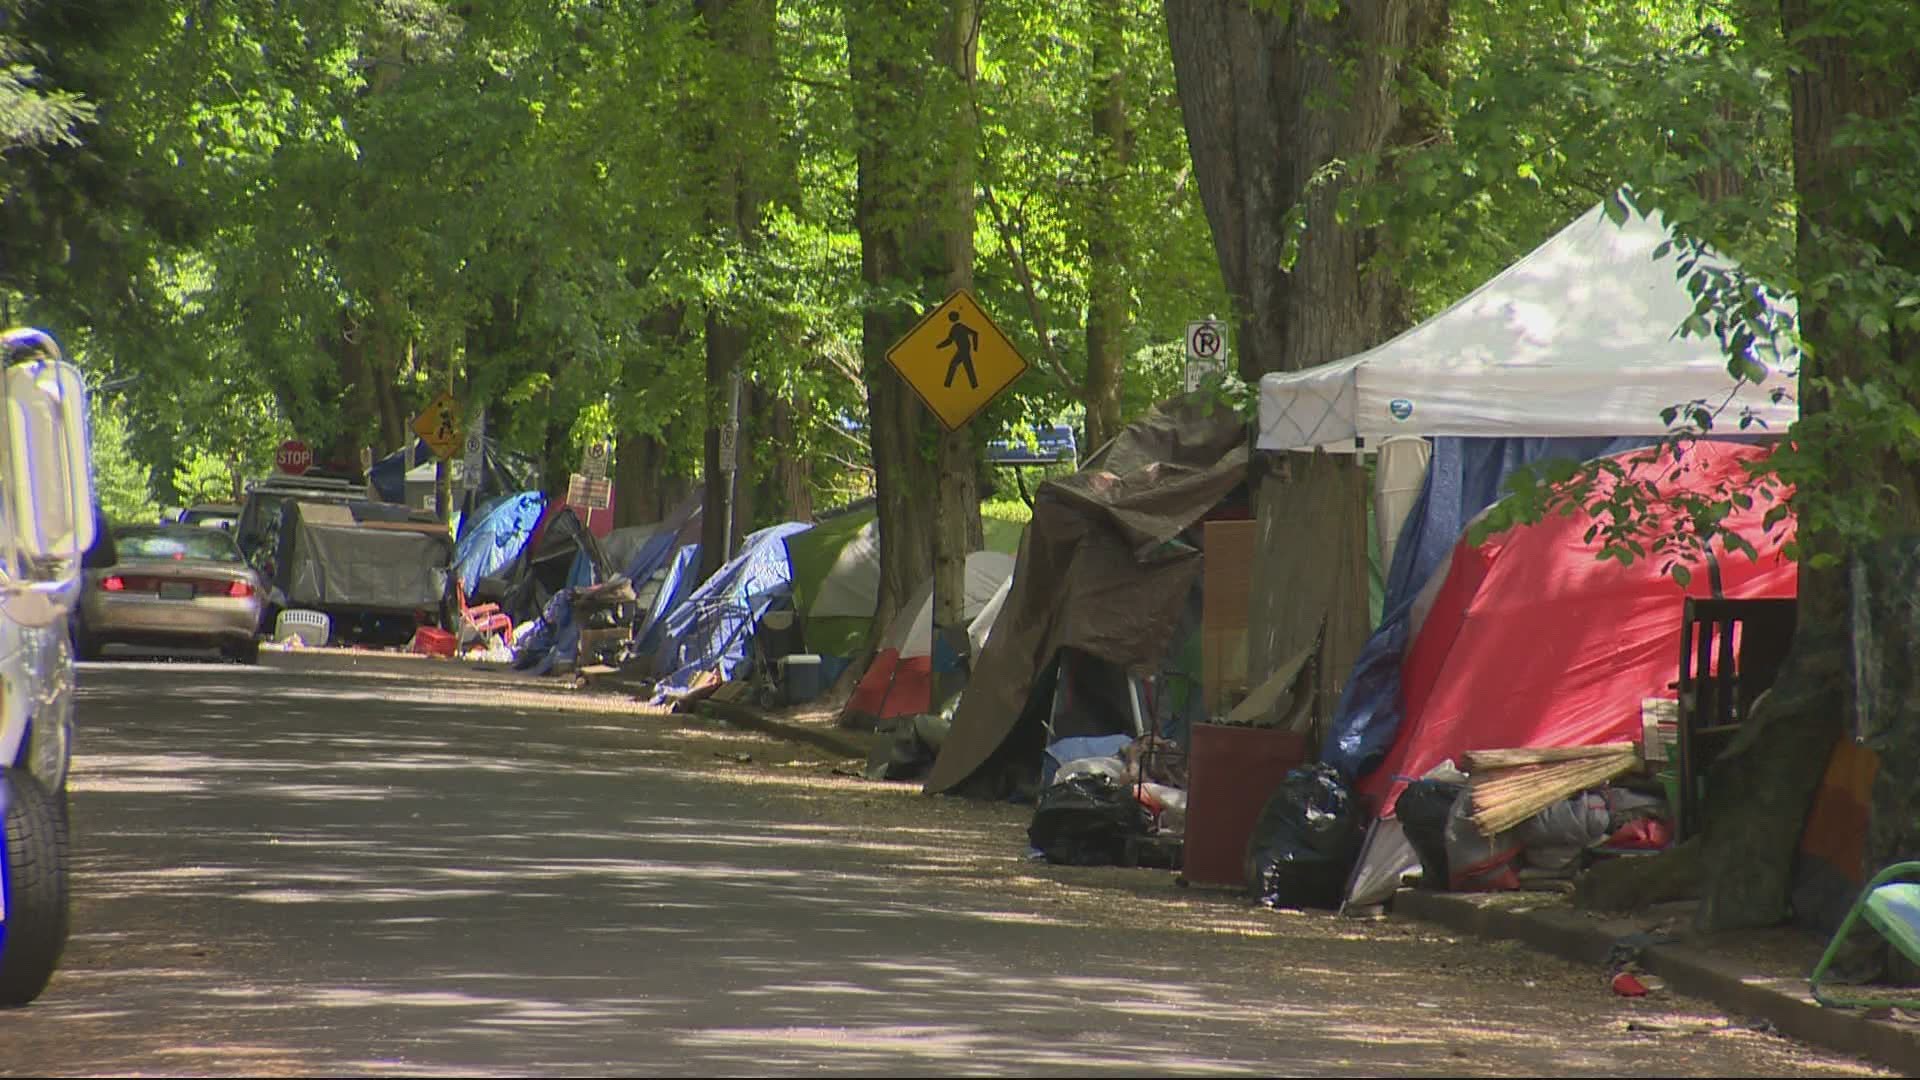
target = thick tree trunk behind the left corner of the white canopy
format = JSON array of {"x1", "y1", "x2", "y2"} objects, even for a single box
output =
[{"x1": 1164, "y1": 0, "x2": 1446, "y2": 721}]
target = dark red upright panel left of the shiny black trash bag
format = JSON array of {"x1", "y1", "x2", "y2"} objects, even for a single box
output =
[{"x1": 1181, "y1": 724, "x2": 1308, "y2": 886}]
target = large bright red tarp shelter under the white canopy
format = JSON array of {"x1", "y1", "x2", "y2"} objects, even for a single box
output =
[{"x1": 1359, "y1": 442, "x2": 1799, "y2": 805}]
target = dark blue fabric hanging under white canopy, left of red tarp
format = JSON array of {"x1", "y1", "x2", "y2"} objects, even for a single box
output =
[{"x1": 1321, "y1": 436, "x2": 1659, "y2": 784}]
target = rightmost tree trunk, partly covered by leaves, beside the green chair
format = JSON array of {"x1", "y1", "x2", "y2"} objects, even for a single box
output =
[{"x1": 1699, "y1": 0, "x2": 1920, "y2": 930}]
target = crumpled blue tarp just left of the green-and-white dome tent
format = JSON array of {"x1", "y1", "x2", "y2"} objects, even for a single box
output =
[{"x1": 655, "y1": 521, "x2": 810, "y2": 690}]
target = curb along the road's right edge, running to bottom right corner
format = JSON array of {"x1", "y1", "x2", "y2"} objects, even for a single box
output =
[{"x1": 1392, "y1": 890, "x2": 1920, "y2": 1076}]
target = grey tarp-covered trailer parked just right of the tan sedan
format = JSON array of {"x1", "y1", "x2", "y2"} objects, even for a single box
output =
[{"x1": 273, "y1": 502, "x2": 453, "y2": 644}]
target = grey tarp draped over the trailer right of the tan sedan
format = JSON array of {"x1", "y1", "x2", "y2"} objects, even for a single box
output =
[{"x1": 276, "y1": 503, "x2": 453, "y2": 615}]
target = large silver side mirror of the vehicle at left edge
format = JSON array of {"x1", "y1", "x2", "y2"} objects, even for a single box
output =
[{"x1": 0, "y1": 331, "x2": 96, "y2": 626}]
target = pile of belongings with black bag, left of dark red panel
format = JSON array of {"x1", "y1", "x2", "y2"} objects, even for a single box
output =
[{"x1": 1027, "y1": 734, "x2": 1187, "y2": 867}]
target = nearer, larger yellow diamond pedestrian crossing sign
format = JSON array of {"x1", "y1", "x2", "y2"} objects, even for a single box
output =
[{"x1": 887, "y1": 288, "x2": 1027, "y2": 430}]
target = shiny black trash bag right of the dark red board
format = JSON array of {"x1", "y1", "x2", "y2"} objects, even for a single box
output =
[{"x1": 1246, "y1": 763, "x2": 1367, "y2": 907}]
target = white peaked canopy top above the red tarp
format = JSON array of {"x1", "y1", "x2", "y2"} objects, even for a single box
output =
[{"x1": 1258, "y1": 206, "x2": 1799, "y2": 452}]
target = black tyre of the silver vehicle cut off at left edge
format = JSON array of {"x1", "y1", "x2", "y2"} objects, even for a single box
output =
[{"x1": 0, "y1": 769, "x2": 67, "y2": 1007}]
